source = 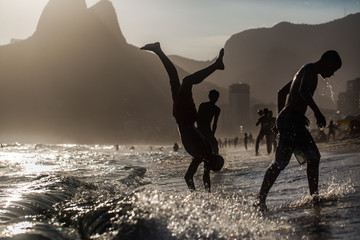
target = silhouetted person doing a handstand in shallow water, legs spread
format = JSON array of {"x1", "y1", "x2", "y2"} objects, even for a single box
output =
[{"x1": 141, "y1": 42, "x2": 224, "y2": 192}]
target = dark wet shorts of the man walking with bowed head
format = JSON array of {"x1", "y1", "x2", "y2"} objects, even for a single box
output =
[{"x1": 271, "y1": 108, "x2": 320, "y2": 170}]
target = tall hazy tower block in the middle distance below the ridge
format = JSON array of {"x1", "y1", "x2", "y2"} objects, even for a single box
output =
[{"x1": 229, "y1": 83, "x2": 250, "y2": 132}]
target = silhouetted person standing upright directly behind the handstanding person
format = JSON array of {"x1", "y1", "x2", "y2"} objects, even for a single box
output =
[{"x1": 197, "y1": 89, "x2": 221, "y2": 154}]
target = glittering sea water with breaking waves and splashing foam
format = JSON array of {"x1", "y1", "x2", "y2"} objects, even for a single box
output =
[{"x1": 0, "y1": 144, "x2": 360, "y2": 239}]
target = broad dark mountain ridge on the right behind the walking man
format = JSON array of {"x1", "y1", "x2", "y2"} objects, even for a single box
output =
[{"x1": 172, "y1": 13, "x2": 360, "y2": 109}]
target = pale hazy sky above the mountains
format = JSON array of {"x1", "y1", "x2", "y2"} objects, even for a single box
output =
[{"x1": 0, "y1": 0, "x2": 360, "y2": 60}]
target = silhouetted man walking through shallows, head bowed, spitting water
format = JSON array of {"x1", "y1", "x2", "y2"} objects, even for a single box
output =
[{"x1": 256, "y1": 50, "x2": 342, "y2": 210}]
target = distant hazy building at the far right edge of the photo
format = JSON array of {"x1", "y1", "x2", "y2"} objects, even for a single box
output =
[{"x1": 337, "y1": 78, "x2": 360, "y2": 115}]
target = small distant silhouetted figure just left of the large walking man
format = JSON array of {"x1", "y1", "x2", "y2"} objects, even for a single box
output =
[{"x1": 255, "y1": 108, "x2": 271, "y2": 156}]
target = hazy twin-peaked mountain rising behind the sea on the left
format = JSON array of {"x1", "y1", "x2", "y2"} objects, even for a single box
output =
[{"x1": 0, "y1": 0, "x2": 224, "y2": 143}]
